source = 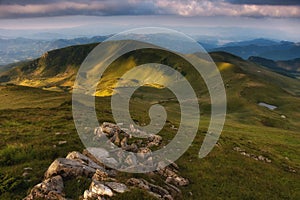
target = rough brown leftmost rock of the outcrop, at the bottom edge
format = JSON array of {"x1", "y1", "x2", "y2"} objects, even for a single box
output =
[{"x1": 24, "y1": 175, "x2": 65, "y2": 200}]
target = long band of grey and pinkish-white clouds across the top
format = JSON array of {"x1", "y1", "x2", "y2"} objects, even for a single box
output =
[{"x1": 0, "y1": 0, "x2": 300, "y2": 18}]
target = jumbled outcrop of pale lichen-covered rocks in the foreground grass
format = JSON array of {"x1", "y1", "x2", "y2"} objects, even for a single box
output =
[{"x1": 24, "y1": 123, "x2": 188, "y2": 200}]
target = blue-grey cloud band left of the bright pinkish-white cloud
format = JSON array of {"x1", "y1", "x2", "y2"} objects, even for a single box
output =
[{"x1": 0, "y1": 0, "x2": 157, "y2": 18}]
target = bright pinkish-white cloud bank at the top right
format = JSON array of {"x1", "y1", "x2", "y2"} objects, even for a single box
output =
[{"x1": 155, "y1": 0, "x2": 300, "y2": 17}]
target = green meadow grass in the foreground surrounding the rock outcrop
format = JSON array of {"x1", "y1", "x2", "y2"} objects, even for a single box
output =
[{"x1": 0, "y1": 82, "x2": 300, "y2": 199}]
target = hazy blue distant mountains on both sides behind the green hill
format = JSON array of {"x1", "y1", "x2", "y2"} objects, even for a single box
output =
[{"x1": 0, "y1": 36, "x2": 300, "y2": 68}]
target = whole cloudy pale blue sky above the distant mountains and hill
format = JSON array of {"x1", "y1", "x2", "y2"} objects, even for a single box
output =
[{"x1": 0, "y1": 0, "x2": 300, "y2": 41}]
